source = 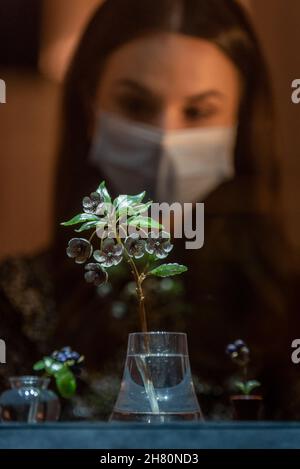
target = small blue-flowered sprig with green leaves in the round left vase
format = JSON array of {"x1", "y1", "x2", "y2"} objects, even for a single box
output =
[{"x1": 33, "y1": 347, "x2": 84, "y2": 399}]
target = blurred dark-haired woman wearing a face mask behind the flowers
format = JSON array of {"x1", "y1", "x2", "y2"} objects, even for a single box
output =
[{"x1": 1, "y1": 0, "x2": 300, "y2": 419}]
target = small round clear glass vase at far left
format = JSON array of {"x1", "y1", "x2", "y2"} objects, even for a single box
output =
[{"x1": 0, "y1": 376, "x2": 61, "y2": 423}]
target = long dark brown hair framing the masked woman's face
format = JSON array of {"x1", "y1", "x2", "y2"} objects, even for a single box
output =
[{"x1": 55, "y1": 0, "x2": 277, "y2": 264}]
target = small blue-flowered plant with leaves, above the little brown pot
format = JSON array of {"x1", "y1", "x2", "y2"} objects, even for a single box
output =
[{"x1": 226, "y1": 339, "x2": 261, "y2": 396}]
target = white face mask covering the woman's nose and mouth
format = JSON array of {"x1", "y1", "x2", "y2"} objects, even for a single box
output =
[{"x1": 90, "y1": 112, "x2": 236, "y2": 203}]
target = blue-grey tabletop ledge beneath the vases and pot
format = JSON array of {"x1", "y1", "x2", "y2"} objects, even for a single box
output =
[{"x1": 0, "y1": 422, "x2": 300, "y2": 449}]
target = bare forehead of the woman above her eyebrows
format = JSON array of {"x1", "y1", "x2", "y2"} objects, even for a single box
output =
[{"x1": 101, "y1": 33, "x2": 239, "y2": 98}]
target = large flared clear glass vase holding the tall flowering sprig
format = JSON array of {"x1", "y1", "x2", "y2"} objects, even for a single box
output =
[{"x1": 110, "y1": 332, "x2": 202, "y2": 423}]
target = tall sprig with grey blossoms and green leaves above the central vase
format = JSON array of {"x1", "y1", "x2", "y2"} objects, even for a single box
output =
[{"x1": 61, "y1": 181, "x2": 187, "y2": 332}]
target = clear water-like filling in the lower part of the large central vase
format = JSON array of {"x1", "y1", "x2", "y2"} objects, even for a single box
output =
[{"x1": 111, "y1": 354, "x2": 201, "y2": 423}]
